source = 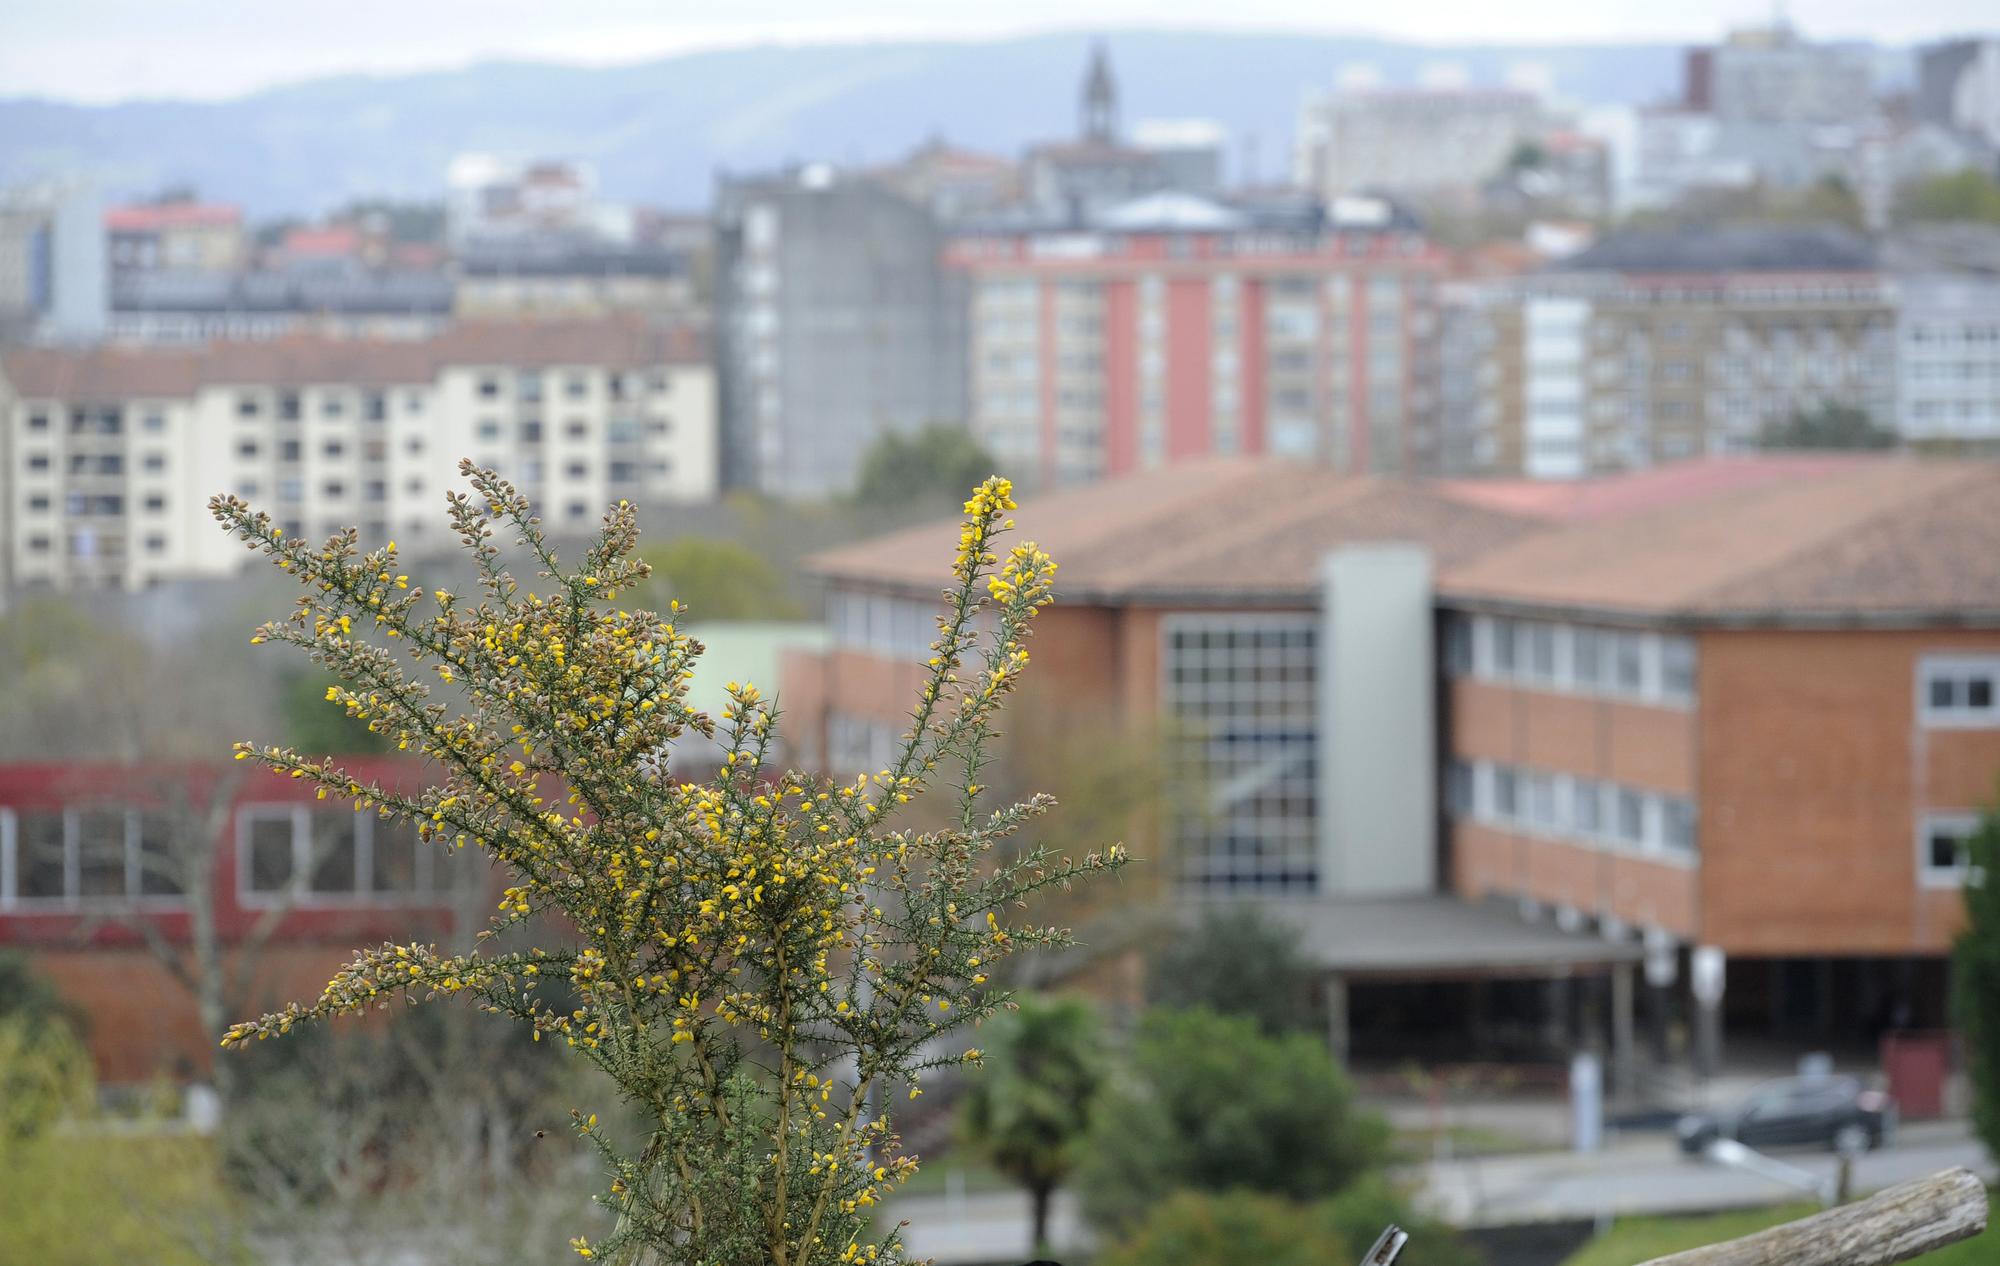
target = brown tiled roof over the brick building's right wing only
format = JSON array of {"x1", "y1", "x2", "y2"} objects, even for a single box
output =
[{"x1": 1438, "y1": 458, "x2": 2000, "y2": 620}]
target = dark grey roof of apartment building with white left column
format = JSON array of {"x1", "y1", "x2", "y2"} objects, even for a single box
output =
[{"x1": 1550, "y1": 224, "x2": 1876, "y2": 272}]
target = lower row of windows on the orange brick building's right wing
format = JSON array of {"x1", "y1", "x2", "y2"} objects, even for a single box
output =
[{"x1": 1444, "y1": 760, "x2": 1698, "y2": 860}]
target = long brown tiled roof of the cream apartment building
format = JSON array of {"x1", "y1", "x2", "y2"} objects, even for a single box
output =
[{"x1": 0, "y1": 320, "x2": 708, "y2": 400}]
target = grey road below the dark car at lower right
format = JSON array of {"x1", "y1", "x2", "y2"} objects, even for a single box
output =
[{"x1": 1406, "y1": 1122, "x2": 2000, "y2": 1226}]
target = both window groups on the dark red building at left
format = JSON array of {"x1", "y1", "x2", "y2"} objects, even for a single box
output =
[{"x1": 0, "y1": 804, "x2": 468, "y2": 908}]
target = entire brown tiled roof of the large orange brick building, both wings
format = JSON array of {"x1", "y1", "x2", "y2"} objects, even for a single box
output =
[{"x1": 808, "y1": 454, "x2": 2000, "y2": 622}]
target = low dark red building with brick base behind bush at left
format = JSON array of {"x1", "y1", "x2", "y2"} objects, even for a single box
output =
[{"x1": 0, "y1": 758, "x2": 480, "y2": 1082}]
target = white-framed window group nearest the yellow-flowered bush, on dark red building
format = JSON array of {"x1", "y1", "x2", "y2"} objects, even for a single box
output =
[{"x1": 236, "y1": 804, "x2": 442, "y2": 906}]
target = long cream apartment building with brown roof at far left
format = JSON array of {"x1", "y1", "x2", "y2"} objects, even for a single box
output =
[{"x1": 0, "y1": 322, "x2": 716, "y2": 588}]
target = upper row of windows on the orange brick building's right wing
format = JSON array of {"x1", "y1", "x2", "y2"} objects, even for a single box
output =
[{"x1": 1444, "y1": 616, "x2": 1696, "y2": 704}]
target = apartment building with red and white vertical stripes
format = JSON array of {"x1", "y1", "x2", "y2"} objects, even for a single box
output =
[{"x1": 948, "y1": 194, "x2": 1444, "y2": 486}]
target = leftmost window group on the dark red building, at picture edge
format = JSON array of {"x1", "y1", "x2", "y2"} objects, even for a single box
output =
[{"x1": 0, "y1": 804, "x2": 182, "y2": 904}]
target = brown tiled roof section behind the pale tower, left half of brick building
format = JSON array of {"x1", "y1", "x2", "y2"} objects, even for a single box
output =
[{"x1": 808, "y1": 458, "x2": 1540, "y2": 604}]
